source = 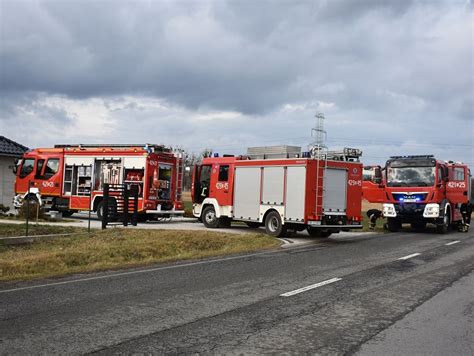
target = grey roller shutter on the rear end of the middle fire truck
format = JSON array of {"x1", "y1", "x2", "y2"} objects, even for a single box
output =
[{"x1": 323, "y1": 168, "x2": 347, "y2": 215}]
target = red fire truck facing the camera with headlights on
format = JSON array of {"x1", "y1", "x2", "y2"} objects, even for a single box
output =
[{"x1": 363, "y1": 155, "x2": 471, "y2": 233}]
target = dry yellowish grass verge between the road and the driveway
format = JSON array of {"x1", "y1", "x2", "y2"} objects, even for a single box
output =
[{"x1": 0, "y1": 229, "x2": 280, "y2": 281}]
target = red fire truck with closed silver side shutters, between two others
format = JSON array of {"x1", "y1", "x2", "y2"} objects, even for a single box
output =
[{"x1": 192, "y1": 149, "x2": 362, "y2": 237}]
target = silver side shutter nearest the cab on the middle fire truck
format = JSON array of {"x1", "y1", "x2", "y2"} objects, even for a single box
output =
[{"x1": 234, "y1": 167, "x2": 261, "y2": 221}]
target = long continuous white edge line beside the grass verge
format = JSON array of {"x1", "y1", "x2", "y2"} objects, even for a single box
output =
[{"x1": 0, "y1": 250, "x2": 286, "y2": 294}]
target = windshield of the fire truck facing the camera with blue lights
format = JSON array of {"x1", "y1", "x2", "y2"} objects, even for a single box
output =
[{"x1": 387, "y1": 167, "x2": 435, "y2": 187}]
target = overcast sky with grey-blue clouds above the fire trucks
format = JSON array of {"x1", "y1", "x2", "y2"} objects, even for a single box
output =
[{"x1": 0, "y1": 0, "x2": 474, "y2": 168}]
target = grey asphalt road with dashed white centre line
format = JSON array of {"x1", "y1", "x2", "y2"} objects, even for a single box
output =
[{"x1": 0, "y1": 228, "x2": 474, "y2": 355}]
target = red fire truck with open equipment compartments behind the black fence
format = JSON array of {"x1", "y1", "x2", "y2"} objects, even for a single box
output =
[{"x1": 14, "y1": 144, "x2": 184, "y2": 219}]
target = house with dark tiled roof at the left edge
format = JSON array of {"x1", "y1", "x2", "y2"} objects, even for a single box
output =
[{"x1": 0, "y1": 136, "x2": 28, "y2": 210}]
